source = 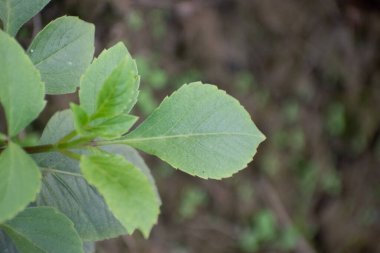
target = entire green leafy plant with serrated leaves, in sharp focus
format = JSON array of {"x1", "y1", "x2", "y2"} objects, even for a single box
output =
[{"x1": 0, "y1": 0, "x2": 265, "y2": 253}]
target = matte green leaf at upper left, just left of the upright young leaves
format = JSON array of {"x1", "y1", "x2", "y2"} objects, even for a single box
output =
[{"x1": 27, "y1": 16, "x2": 95, "y2": 94}]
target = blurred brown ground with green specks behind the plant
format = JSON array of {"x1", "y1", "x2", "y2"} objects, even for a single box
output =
[{"x1": 10, "y1": 0, "x2": 380, "y2": 253}]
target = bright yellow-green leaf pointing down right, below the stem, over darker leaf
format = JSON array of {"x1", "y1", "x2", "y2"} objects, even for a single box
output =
[{"x1": 80, "y1": 153, "x2": 160, "y2": 237}]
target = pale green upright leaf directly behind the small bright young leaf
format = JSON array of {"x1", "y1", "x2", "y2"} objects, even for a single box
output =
[{"x1": 79, "y1": 42, "x2": 139, "y2": 115}]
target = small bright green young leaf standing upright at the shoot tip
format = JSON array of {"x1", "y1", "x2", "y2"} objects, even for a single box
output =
[{"x1": 91, "y1": 57, "x2": 139, "y2": 119}]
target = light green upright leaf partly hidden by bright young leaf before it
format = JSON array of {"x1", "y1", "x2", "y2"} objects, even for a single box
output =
[{"x1": 79, "y1": 42, "x2": 138, "y2": 115}]
